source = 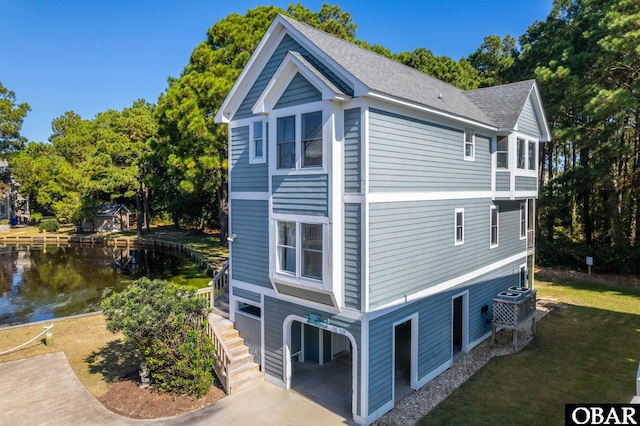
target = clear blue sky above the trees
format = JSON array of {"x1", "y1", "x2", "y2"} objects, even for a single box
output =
[{"x1": 0, "y1": 0, "x2": 552, "y2": 142}]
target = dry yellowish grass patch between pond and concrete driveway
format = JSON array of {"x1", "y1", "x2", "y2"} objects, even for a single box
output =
[{"x1": 0, "y1": 315, "x2": 138, "y2": 396}]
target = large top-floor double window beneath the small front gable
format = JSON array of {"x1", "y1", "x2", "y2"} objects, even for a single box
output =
[{"x1": 276, "y1": 111, "x2": 323, "y2": 169}]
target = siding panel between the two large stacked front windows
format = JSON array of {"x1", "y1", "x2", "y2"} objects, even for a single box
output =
[{"x1": 272, "y1": 174, "x2": 329, "y2": 216}]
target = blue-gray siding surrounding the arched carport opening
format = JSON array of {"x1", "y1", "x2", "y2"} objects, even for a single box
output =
[{"x1": 263, "y1": 297, "x2": 363, "y2": 415}]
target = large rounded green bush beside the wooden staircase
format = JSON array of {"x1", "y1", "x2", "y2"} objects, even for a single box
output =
[{"x1": 102, "y1": 278, "x2": 214, "y2": 396}]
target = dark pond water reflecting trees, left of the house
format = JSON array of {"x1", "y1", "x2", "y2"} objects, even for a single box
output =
[{"x1": 0, "y1": 245, "x2": 210, "y2": 327}]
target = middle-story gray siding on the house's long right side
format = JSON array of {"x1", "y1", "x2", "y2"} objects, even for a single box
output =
[{"x1": 369, "y1": 199, "x2": 525, "y2": 308}]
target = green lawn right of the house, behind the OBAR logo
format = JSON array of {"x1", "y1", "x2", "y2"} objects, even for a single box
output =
[{"x1": 418, "y1": 279, "x2": 640, "y2": 425}]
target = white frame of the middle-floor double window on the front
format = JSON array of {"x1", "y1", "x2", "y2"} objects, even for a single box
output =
[{"x1": 272, "y1": 217, "x2": 331, "y2": 289}]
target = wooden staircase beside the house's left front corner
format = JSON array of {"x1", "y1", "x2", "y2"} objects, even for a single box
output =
[{"x1": 209, "y1": 313, "x2": 264, "y2": 395}]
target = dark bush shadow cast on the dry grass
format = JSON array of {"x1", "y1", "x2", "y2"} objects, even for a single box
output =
[{"x1": 84, "y1": 339, "x2": 140, "y2": 383}]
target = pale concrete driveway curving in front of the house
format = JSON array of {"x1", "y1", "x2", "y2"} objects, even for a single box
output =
[{"x1": 0, "y1": 352, "x2": 353, "y2": 426}]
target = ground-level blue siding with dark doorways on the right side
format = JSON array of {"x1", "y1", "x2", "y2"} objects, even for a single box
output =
[{"x1": 368, "y1": 262, "x2": 519, "y2": 414}]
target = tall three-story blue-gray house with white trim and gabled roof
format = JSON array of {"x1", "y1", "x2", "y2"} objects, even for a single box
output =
[{"x1": 216, "y1": 16, "x2": 549, "y2": 424}]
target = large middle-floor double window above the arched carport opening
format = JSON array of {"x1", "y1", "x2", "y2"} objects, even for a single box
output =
[{"x1": 277, "y1": 221, "x2": 323, "y2": 281}]
